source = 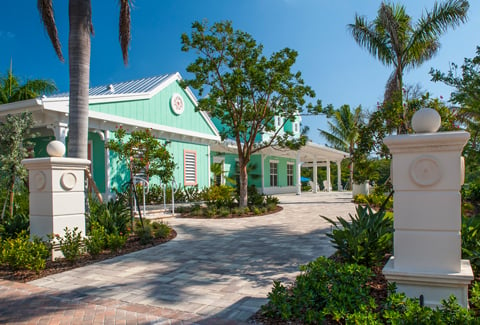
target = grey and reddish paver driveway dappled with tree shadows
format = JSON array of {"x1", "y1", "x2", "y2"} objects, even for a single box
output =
[{"x1": 0, "y1": 192, "x2": 354, "y2": 324}]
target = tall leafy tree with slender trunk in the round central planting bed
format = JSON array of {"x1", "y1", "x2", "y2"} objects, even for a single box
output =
[{"x1": 182, "y1": 21, "x2": 315, "y2": 206}]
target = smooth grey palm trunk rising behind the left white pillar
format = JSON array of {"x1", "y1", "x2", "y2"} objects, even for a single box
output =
[{"x1": 68, "y1": 0, "x2": 92, "y2": 159}]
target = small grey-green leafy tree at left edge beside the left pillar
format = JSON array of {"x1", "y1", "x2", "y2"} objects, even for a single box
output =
[{"x1": 0, "y1": 112, "x2": 33, "y2": 219}]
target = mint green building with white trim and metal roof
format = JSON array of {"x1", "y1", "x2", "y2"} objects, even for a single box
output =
[{"x1": 0, "y1": 73, "x2": 347, "y2": 198}]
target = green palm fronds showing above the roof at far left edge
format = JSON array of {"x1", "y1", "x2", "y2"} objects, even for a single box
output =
[{"x1": 0, "y1": 69, "x2": 57, "y2": 104}]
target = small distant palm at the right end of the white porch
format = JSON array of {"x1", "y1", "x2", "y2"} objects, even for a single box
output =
[{"x1": 318, "y1": 105, "x2": 363, "y2": 188}]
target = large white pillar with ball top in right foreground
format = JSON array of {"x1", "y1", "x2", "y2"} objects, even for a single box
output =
[{"x1": 383, "y1": 109, "x2": 473, "y2": 307}]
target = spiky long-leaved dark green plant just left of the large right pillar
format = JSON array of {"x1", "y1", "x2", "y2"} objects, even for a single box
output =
[{"x1": 321, "y1": 205, "x2": 393, "y2": 266}]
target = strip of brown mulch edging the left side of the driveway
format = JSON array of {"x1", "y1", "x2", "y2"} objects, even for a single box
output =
[{"x1": 0, "y1": 229, "x2": 177, "y2": 282}]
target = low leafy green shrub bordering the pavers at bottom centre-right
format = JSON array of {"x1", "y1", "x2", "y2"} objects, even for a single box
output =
[{"x1": 262, "y1": 257, "x2": 376, "y2": 324}]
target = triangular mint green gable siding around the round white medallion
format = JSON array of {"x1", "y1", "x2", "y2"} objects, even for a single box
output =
[{"x1": 90, "y1": 82, "x2": 215, "y2": 135}]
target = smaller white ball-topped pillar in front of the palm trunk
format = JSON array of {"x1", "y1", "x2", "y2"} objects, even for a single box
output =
[{"x1": 22, "y1": 141, "x2": 90, "y2": 258}]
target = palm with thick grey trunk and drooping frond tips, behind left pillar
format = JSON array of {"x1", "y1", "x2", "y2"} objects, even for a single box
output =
[{"x1": 37, "y1": 0, "x2": 130, "y2": 159}]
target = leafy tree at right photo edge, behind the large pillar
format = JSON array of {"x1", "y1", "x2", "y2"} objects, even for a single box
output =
[{"x1": 430, "y1": 47, "x2": 480, "y2": 180}]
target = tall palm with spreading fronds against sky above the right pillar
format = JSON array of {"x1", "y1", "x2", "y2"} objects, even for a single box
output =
[{"x1": 348, "y1": 0, "x2": 469, "y2": 133}]
